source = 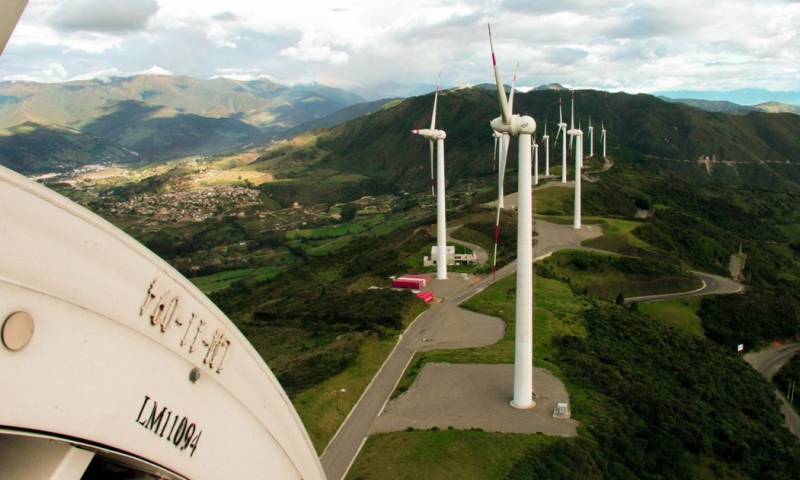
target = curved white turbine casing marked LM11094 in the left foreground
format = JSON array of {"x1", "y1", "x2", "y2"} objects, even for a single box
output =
[{"x1": 0, "y1": 167, "x2": 324, "y2": 480}]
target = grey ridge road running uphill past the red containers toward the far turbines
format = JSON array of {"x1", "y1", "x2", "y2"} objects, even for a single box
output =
[{"x1": 321, "y1": 220, "x2": 602, "y2": 480}]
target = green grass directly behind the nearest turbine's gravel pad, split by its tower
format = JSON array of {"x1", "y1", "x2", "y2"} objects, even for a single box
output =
[{"x1": 395, "y1": 276, "x2": 590, "y2": 395}]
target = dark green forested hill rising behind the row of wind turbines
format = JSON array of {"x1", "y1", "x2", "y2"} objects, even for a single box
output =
[{"x1": 318, "y1": 86, "x2": 800, "y2": 190}]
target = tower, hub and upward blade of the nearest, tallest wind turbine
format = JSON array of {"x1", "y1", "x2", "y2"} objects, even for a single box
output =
[{"x1": 489, "y1": 25, "x2": 536, "y2": 408}]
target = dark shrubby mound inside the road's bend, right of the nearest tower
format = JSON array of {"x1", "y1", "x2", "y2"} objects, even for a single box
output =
[{"x1": 540, "y1": 250, "x2": 701, "y2": 301}]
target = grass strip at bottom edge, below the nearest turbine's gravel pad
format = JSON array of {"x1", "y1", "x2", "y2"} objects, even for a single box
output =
[{"x1": 347, "y1": 429, "x2": 555, "y2": 480}]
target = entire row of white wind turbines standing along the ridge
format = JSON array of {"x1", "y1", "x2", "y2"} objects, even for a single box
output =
[{"x1": 412, "y1": 25, "x2": 606, "y2": 409}]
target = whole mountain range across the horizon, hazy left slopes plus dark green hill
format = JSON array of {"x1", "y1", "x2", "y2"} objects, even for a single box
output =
[{"x1": 0, "y1": 75, "x2": 800, "y2": 183}]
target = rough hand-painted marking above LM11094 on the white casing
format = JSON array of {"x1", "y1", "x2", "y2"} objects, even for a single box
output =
[{"x1": 139, "y1": 279, "x2": 231, "y2": 373}]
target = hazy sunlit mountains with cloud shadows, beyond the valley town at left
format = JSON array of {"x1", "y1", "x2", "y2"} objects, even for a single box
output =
[{"x1": 0, "y1": 75, "x2": 363, "y2": 173}]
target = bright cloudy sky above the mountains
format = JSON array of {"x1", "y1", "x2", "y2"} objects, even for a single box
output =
[{"x1": 0, "y1": 0, "x2": 800, "y2": 96}]
